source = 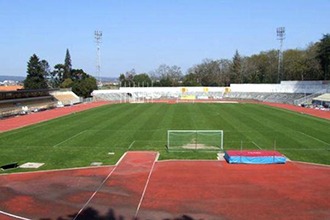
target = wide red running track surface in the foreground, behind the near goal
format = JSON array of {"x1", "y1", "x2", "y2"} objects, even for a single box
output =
[{"x1": 0, "y1": 152, "x2": 330, "y2": 220}]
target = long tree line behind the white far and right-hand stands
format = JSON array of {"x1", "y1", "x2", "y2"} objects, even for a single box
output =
[{"x1": 119, "y1": 34, "x2": 330, "y2": 87}]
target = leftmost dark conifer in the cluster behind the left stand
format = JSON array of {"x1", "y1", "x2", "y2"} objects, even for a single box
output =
[{"x1": 24, "y1": 54, "x2": 50, "y2": 89}]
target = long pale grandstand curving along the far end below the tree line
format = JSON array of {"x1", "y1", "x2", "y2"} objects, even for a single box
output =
[{"x1": 92, "y1": 81, "x2": 330, "y2": 105}]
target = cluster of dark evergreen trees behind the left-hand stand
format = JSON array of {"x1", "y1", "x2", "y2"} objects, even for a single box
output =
[{"x1": 24, "y1": 49, "x2": 97, "y2": 98}]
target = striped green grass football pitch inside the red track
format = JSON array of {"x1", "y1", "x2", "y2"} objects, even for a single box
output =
[{"x1": 0, "y1": 104, "x2": 330, "y2": 171}]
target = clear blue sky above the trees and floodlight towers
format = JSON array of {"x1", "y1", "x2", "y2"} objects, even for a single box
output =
[{"x1": 0, "y1": 0, "x2": 330, "y2": 77}]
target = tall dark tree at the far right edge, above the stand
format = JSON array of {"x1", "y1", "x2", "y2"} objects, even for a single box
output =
[{"x1": 317, "y1": 34, "x2": 330, "y2": 80}]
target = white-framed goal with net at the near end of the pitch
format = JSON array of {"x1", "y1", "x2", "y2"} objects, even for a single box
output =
[{"x1": 167, "y1": 130, "x2": 223, "y2": 151}]
